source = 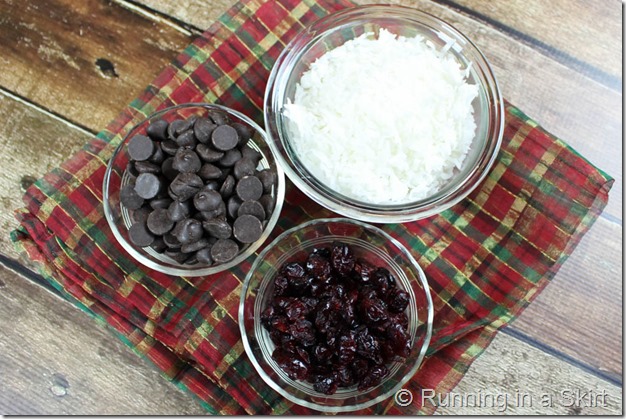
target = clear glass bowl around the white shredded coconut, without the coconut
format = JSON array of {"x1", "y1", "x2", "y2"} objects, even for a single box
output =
[{"x1": 264, "y1": 5, "x2": 504, "y2": 223}]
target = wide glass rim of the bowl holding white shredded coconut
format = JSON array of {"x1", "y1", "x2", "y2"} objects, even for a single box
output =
[{"x1": 264, "y1": 4, "x2": 504, "y2": 223}]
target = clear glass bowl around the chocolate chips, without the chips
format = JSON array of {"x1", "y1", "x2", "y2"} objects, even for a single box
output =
[{"x1": 103, "y1": 103, "x2": 285, "y2": 277}]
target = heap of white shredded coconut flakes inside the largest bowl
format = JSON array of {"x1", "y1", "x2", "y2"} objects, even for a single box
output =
[{"x1": 284, "y1": 29, "x2": 478, "y2": 204}]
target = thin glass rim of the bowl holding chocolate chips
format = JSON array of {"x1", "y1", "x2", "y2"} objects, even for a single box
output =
[{"x1": 102, "y1": 102, "x2": 286, "y2": 277}]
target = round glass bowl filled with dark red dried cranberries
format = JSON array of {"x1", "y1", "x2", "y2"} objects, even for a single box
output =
[{"x1": 239, "y1": 218, "x2": 433, "y2": 412}]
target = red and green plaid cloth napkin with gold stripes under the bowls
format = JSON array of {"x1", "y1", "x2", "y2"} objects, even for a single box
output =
[{"x1": 12, "y1": 0, "x2": 612, "y2": 414}]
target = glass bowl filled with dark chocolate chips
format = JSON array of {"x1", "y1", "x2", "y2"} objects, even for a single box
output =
[{"x1": 103, "y1": 103, "x2": 285, "y2": 276}]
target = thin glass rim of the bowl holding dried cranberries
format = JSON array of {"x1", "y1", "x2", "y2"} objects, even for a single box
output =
[{"x1": 238, "y1": 217, "x2": 434, "y2": 413}]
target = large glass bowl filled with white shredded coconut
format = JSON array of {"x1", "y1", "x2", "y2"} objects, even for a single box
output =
[{"x1": 265, "y1": 5, "x2": 504, "y2": 223}]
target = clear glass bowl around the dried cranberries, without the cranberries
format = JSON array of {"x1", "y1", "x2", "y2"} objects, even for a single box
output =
[{"x1": 239, "y1": 218, "x2": 433, "y2": 412}]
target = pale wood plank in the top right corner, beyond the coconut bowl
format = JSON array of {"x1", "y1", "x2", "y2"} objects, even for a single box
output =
[{"x1": 448, "y1": 0, "x2": 622, "y2": 84}]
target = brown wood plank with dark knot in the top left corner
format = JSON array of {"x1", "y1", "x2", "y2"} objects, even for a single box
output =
[{"x1": 0, "y1": 0, "x2": 191, "y2": 131}]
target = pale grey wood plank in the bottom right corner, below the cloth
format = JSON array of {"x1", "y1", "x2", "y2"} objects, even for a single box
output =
[{"x1": 434, "y1": 333, "x2": 623, "y2": 416}]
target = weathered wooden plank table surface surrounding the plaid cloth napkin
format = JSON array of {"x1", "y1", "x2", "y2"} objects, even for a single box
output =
[{"x1": 0, "y1": 0, "x2": 623, "y2": 415}]
